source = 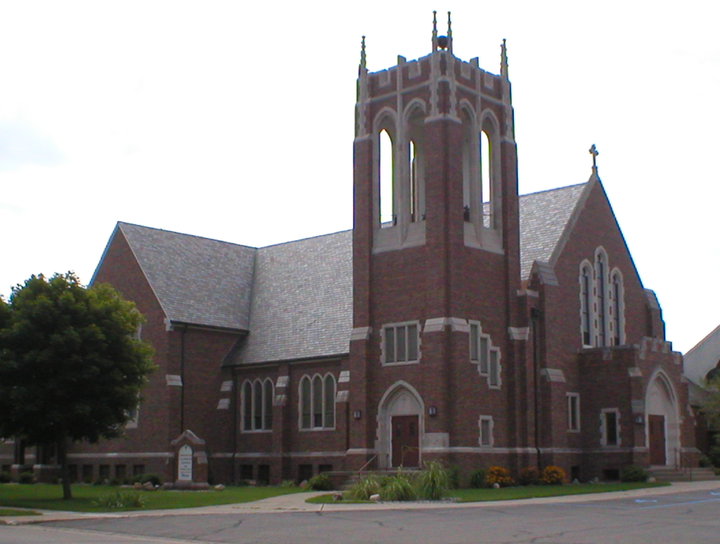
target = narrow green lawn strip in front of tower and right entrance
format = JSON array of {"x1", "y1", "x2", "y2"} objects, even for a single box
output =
[{"x1": 307, "y1": 482, "x2": 670, "y2": 504}]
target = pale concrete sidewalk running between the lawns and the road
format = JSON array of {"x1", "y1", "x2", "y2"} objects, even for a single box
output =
[{"x1": 0, "y1": 480, "x2": 720, "y2": 525}]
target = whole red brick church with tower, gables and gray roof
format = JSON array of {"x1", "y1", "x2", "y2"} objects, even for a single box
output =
[{"x1": 1, "y1": 15, "x2": 697, "y2": 483}]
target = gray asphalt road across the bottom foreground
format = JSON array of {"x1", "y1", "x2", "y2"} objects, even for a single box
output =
[{"x1": 0, "y1": 488, "x2": 720, "y2": 544}]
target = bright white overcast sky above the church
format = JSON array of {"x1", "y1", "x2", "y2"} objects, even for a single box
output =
[{"x1": 0, "y1": 0, "x2": 720, "y2": 351}]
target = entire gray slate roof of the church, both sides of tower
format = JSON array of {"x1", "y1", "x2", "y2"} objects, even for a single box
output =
[{"x1": 108, "y1": 183, "x2": 588, "y2": 364}]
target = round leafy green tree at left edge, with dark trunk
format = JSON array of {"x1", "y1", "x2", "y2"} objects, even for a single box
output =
[{"x1": 0, "y1": 272, "x2": 155, "y2": 499}]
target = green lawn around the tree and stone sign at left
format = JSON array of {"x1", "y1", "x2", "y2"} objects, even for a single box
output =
[{"x1": 0, "y1": 484, "x2": 301, "y2": 512}]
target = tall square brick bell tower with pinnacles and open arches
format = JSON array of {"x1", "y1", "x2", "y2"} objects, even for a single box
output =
[{"x1": 348, "y1": 13, "x2": 521, "y2": 467}]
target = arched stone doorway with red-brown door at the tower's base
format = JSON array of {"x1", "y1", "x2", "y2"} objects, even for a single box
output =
[{"x1": 376, "y1": 381, "x2": 424, "y2": 468}]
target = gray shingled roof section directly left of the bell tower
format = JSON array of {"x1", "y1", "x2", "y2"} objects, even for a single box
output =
[{"x1": 241, "y1": 227, "x2": 352, "y2": 363}]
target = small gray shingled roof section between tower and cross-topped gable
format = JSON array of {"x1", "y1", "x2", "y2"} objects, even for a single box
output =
[{"x1": 520, "y1": 183, "x2": 587, "y2": 279}]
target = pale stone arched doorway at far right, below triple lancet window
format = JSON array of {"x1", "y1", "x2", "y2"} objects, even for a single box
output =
[{"x1": 645, "y1": 371, "x2": 680, "y2": 466}]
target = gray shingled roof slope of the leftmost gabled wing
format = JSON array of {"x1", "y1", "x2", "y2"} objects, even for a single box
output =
[{"x1": 117, "y1": 223, "x2": 257, "y2": 330}]
